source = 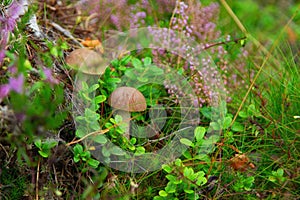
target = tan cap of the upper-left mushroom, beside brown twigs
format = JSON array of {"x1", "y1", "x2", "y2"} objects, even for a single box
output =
[{"x1": 66, "y1": 48, "x2": 106, "y2": 75}]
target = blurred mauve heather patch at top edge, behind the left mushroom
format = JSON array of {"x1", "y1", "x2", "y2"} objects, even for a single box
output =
[{"x1": 76, "y1": 0, "x2": 175, "y2": 31}]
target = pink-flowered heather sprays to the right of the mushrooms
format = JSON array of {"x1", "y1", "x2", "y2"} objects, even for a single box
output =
[{"x1": 149, "y1": 1, "x2": 247, "y2": 107}]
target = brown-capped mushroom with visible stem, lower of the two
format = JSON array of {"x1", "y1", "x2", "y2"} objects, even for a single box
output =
[{"x1": 108, "y1": 87, "x2": 147, "y2": 139}]
